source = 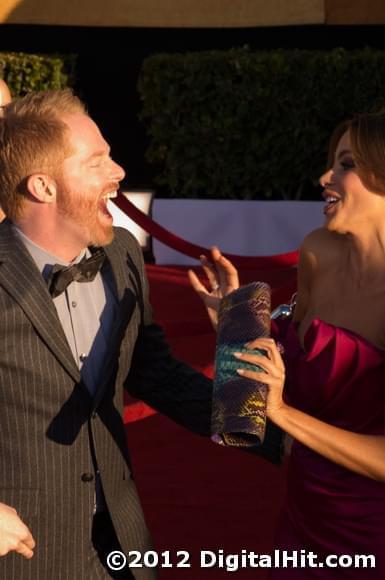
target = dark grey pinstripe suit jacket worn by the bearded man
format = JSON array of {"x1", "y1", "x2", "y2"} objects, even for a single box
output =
[{"x1": 0, "y1": 221, "x2": 211, "y2": 580}]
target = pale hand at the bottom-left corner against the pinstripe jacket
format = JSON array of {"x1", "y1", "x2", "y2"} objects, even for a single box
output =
[{"x1": 0, "y1": 503, "x2": 35, "y2": 559}]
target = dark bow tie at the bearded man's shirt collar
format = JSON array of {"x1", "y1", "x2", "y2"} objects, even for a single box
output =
[{"x1": 47, "y1": 248, "x2": 106, "y2": 298}]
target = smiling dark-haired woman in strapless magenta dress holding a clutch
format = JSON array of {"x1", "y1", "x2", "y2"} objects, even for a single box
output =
[{"x1": 190, "y1": 113, "x2": 385, "y2": 580}]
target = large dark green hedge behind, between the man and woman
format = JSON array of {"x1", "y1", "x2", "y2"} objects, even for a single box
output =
[{"x1": 138, "y1": 48, "x2": 385, "y2": 199}]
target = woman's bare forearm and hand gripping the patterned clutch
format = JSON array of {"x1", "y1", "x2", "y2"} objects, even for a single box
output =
[{"x1": 232, "y1": 338, "x2": 385, "y2": 482}]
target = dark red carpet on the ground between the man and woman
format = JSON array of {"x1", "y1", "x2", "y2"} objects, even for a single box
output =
[{"x1": 125, "y1": 266, "x2": 295, "y2": 580}]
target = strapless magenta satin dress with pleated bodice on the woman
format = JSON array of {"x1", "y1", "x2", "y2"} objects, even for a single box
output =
[{"x1": 271, "y1": 319, "x2": 385, "y2": 580}]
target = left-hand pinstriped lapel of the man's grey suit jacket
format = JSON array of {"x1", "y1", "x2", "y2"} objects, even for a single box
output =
[{"x1": 0, "y1": 221, "x2": 80, "y2": 383}]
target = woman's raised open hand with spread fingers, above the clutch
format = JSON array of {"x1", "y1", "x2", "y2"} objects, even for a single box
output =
[{"x1": 188, "y1": 247, "x2": 239, "y2": 330}]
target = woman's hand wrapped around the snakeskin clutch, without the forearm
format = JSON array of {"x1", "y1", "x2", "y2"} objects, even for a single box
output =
[{"x1": 234, "y1": 338, "x2": 286, "y2": 422}]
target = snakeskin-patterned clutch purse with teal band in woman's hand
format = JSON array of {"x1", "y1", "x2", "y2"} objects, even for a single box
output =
[{"x1": 211, "y1": 282, "x2": 282, "y2": 462}]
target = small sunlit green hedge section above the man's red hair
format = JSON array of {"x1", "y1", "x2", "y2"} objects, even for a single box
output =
[{"x1": 0, "y1": 52, "x2": 75, "y2": 96}]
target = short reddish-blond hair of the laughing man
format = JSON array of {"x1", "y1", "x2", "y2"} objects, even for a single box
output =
[{"x1": 0, "y1": 89, "x2": 86, "y2": 220}]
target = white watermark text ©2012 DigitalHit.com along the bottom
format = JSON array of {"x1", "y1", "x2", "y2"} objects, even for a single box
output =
[{"x1": 107, "y1": 549, "x2": 376, "y2": 572}]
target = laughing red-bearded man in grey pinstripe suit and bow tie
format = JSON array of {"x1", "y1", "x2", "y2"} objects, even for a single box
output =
[{"x1": 0, "y1": 90, "x2": 211, "y2": 580}]
